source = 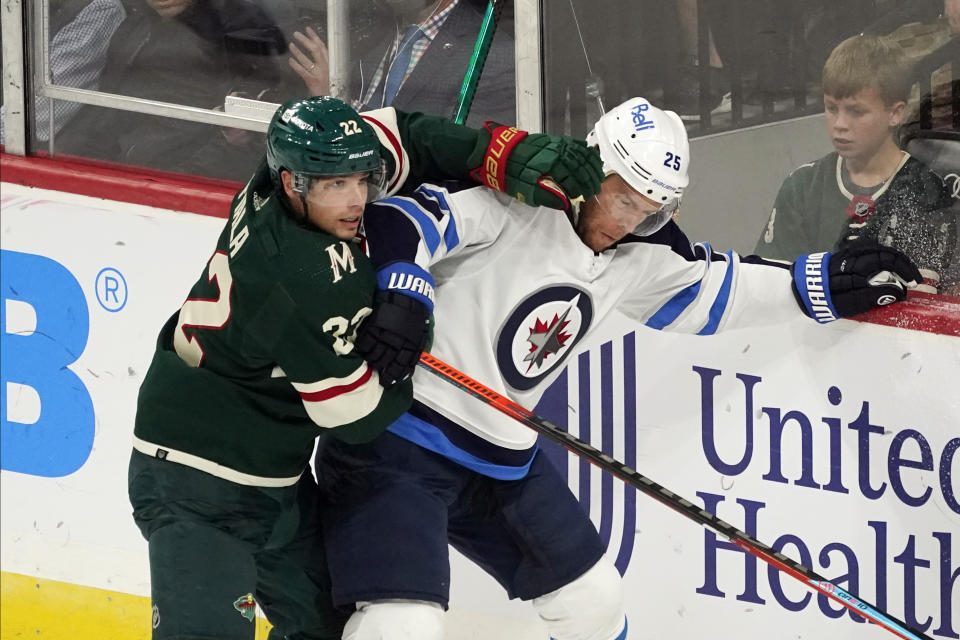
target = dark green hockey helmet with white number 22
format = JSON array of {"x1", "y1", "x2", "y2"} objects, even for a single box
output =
[{"x1": 267, "y1": 96, "x2": 384, "y2": 200}]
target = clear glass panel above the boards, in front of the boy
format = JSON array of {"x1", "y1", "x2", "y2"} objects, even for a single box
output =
[{"x1": 542, "y1": 0, "x2": 960, "y2": 293}]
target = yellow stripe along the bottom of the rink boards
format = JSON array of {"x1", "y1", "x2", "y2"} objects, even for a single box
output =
[{"x1": 0, "y1": 572, "x2": 270, "y2": 640}]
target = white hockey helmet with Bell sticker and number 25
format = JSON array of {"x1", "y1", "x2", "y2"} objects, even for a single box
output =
[{"x1": 587, "y1": 98, "x2": 690, "y2": 236}]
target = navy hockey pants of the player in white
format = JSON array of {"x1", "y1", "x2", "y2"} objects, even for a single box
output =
[{"x1": 316, "y1": 432, "x2": 604, "y2": 607}]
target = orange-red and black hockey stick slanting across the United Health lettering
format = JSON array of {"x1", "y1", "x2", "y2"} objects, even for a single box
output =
[{"x1": 419, "y1": 353, "x2": 932, "y2": 640}]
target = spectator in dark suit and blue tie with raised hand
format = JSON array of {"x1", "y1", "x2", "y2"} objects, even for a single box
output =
[{"x1": 290, "y1": 0, "x2": 516, "y2": 124}]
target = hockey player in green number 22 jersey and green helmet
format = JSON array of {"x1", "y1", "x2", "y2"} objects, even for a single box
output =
[{"x1": 129, "y1": 97, "x2": 602, "y2": 639}]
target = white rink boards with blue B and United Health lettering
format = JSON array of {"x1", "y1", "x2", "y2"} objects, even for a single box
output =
[{"x1": 0, "y1": 183, "x2": 960, "y2": 640}]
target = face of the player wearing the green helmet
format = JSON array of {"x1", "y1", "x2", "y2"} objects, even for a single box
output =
[{"x1": 281, "y1": 171, "x2": 370, "y2": 240}]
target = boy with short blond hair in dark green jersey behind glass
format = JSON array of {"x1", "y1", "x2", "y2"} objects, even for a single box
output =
[{"x1": 756, "y1": 36, "x2": 960, "y2": 291}]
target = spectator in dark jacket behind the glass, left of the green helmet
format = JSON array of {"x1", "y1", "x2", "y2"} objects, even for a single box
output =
[{"x1": 60, "y1": 0, "x2": 286, "y2": 179}]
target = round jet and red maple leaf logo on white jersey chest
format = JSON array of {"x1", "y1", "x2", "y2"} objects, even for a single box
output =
[{"x1": 496, "y1": 285, "x2": 593, "y2": 390}]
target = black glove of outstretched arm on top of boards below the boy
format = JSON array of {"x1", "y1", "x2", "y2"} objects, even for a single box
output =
[{"x1": 793, "y1": 244, "x2": 923, "y2": 324}]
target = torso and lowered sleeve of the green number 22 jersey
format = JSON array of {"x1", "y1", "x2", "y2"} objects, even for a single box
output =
[{"x1": 134, "y1": 164, "x2": 412, "y2": 486}]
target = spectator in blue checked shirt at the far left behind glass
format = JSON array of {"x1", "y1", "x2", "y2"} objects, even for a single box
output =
[{"x1": 0, "y1": 0, "x2": 126, "y2": 143}]
